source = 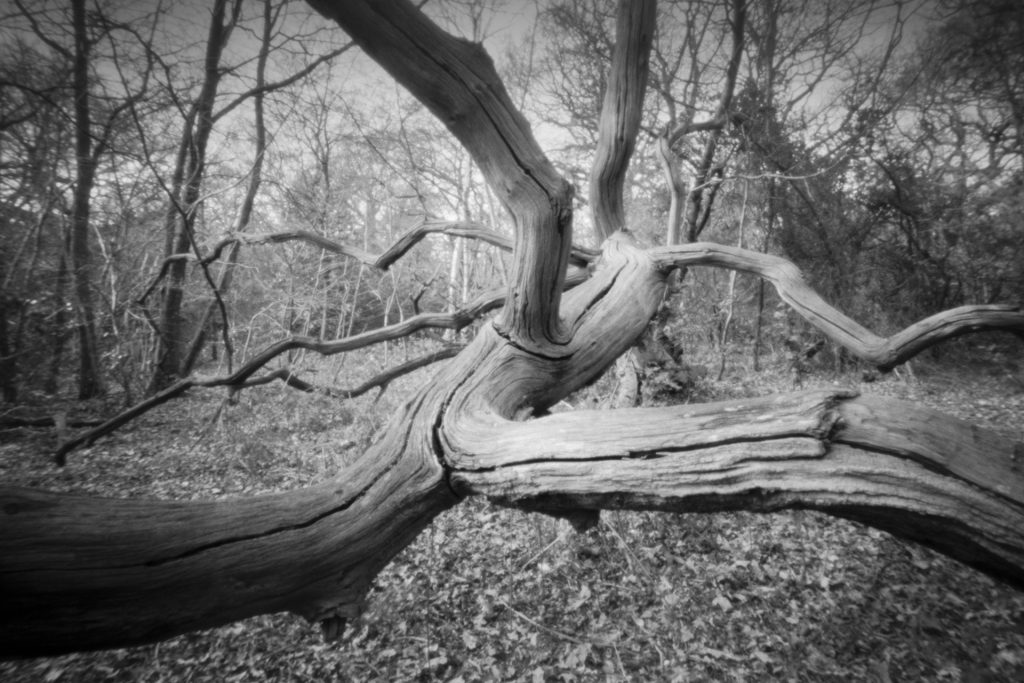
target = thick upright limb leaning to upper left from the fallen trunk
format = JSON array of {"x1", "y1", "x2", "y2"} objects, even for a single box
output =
[{"x1": 310, "y1": 0, "x2": 572, "y2": 348}]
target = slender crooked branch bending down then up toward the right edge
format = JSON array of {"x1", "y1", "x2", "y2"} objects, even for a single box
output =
[{"x1": 651, "y1": 242, "x2": 1024, "y2": 371}]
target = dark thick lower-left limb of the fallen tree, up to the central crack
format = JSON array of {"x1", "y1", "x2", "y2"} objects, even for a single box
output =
[{"x1": 0, "y1": 385, "x2": 455, "y2": 656}]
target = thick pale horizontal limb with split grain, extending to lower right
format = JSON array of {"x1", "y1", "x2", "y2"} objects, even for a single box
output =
[{"x1": 447, "y1": 391, "x2": 1024, "y2": 588}]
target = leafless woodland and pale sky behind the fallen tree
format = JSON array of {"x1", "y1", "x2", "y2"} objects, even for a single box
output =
[{"x1": 0, "y1": 0, "x2": 1024, "y2": 403}]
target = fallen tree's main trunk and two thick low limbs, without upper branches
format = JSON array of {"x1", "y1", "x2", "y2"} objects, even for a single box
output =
[{"x1": 0, "y1": 240, "x2": 1024, "y2": 656}]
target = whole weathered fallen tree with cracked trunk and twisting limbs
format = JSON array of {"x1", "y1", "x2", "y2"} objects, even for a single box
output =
[{"x1": 0, "y1": 0, "x2": 1024, "y2": 656}]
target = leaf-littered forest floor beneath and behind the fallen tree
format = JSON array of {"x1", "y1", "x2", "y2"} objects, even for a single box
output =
[{"x1": 0, "y1": 344, "x2": 1024, "y2": 683}]
